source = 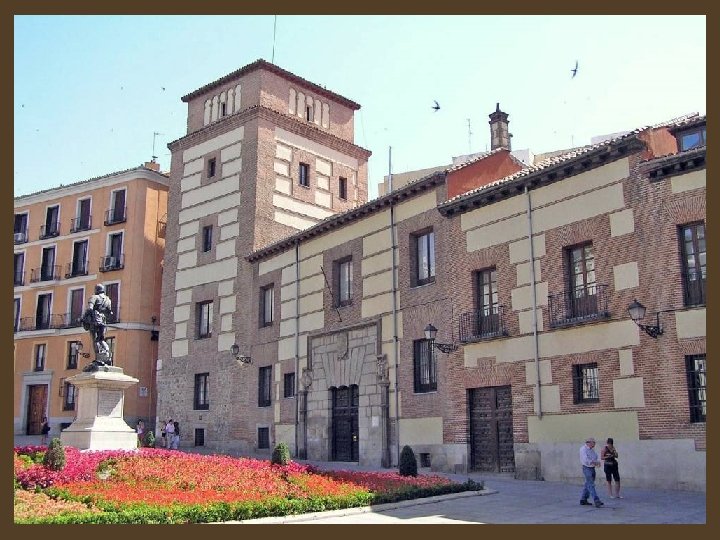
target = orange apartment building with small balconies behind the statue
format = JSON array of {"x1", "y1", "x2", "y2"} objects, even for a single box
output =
[{"x1": 13, "y1": 162, "x2": 168, "y2": 435}]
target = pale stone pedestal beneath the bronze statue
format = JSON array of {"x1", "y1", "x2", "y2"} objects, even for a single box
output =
[{"x1": 60, "y1": 366, "x2": 138, "y2": 450}]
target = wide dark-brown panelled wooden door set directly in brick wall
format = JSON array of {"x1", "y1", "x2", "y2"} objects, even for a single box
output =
[{"x1": 468, "y1": 386, "x2": 515, "y2": 472}]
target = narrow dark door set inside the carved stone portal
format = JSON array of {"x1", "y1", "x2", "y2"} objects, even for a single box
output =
[{"x1": 332, "y1": 384, "x2": 359, "y2": 461}]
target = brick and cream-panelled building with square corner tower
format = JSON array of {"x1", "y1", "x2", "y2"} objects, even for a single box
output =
[{"x1": 158, "y1": 62, "x2": 706, "y2": 489}]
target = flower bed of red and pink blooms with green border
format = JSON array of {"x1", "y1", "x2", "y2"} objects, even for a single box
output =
[{"x1": 14, "y1": 447, "x2": 481, "y2": 523}]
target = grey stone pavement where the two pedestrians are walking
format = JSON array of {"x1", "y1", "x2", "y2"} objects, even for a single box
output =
[{"x1": 15, "y1": 436, "x2": 706, "y2": 524}]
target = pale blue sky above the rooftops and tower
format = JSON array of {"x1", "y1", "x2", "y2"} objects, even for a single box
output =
[{"x1": 14, "y1": 15, "x2": 706, "y2": 197}]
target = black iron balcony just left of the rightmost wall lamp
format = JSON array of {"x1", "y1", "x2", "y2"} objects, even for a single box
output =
[{"x1": 548, "y1": 284, "x2": 610, "y2": 328}]
